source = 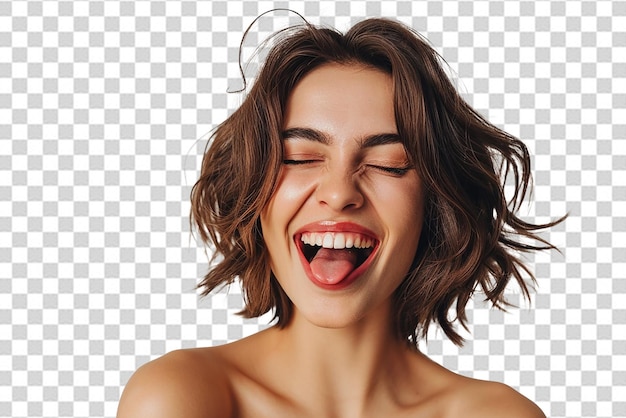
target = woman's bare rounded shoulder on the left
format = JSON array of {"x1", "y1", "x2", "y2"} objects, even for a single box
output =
[{"x1": 117, "y1": 349, "x2": 234, "y2": 418}]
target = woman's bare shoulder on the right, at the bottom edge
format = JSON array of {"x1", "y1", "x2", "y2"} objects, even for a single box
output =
[{"x1": 446, "y1": 379, "x2": 546, "y2": 418}]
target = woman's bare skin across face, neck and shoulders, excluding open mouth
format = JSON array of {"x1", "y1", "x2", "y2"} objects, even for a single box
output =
[{"x1": 118, "y1": 65, "x2": 545, "y2": 418}]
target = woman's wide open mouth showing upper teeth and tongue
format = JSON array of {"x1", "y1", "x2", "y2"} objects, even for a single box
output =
[{"x1": 296, "y1": 232, "x2": 378, "y2": 286}]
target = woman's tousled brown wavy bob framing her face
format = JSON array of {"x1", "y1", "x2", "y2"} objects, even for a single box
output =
[{"x1": 191, "y1": 18, "x2": 562, "y2": 346}]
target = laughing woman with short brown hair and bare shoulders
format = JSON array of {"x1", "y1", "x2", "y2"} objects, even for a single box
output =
[{"x1": 118, "y1": 19, "x2": 554, "y2": 418}]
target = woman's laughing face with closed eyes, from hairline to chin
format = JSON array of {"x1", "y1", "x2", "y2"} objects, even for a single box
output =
[{"x1": 261, "y1": 64, "x2": 423, "y2": 328}]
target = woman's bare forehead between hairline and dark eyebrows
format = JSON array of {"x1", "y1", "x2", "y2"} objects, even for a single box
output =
[{"x1": 284, "y1": 64, "x2": 397, "y2": 134}]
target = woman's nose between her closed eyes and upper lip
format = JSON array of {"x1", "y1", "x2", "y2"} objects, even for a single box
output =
[{"x1": 315, "y1": 170, "x2": 365, "y2": 212}]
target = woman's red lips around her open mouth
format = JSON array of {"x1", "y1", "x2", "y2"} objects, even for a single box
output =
[{"x1": 293, "y1": 221, "x2": 380, "y2": 290}]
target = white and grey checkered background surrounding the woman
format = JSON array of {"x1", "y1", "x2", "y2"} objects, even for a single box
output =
[{"x1": 0, "y1": 0, "x2": 626, "y2": 417}]
